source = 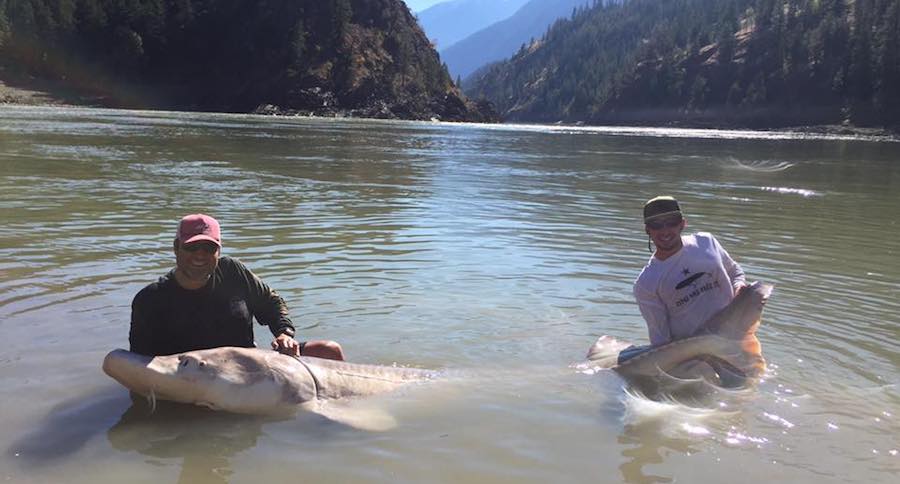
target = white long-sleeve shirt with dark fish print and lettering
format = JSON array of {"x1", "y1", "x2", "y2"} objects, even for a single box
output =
[{"x1": 634, "y1": 232, "x2": 745, "y2": 346}]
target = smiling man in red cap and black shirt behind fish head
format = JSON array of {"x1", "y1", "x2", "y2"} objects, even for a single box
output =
[{"x1": 129, "y1": 214, "x2": 344, "y2": 360}]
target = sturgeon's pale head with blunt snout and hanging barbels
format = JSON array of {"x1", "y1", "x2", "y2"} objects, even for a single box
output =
[{"x1": 103, "y1": 347, "x2": 316, "y2": 414}]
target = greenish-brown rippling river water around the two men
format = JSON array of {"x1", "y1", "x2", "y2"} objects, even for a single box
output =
[{"x1": 0, "y1": 107, "x2": 900, "y2": 483}]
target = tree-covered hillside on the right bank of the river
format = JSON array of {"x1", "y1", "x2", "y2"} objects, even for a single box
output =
[{"x1": 466, "y1": 0, "x2": 900, "y2": 127}]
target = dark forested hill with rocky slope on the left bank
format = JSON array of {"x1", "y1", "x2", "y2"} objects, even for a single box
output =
[{"x1": 0, "y1": 0, "x2": 492, "y2": 120}]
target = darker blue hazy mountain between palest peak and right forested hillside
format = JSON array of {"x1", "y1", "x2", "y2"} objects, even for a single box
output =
[{"x1": 440, "y1": 0, "x2": 594, "y2": 78}]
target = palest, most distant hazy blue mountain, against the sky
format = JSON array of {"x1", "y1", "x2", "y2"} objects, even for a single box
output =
[{"x1": 417, "y1": 0, "x2": 528, "y2": 50}]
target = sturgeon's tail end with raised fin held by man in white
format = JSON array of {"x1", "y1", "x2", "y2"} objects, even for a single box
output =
[{"x1": 579, "y1": 282, "x2": 773, "y2": 386}]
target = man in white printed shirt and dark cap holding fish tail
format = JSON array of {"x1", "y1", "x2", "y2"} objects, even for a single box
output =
[{"x1": 634, "y1": 196, "x2": 747, "y2": 346}]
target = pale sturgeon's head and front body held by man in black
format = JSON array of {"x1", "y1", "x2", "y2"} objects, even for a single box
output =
[{"x1": 103, "y1": 346, "x2": 435, "y2": 427}]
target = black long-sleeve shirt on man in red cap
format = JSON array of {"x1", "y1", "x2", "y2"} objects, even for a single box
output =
[{"x1": 128, "y1": 257, "x2": 294, "y2": 356}]
